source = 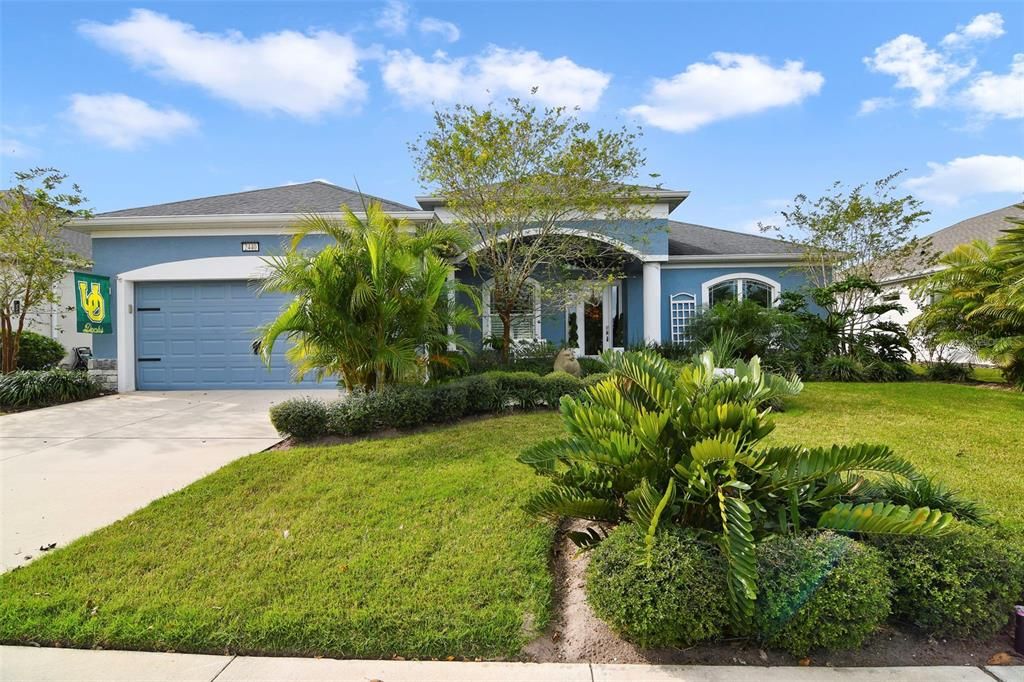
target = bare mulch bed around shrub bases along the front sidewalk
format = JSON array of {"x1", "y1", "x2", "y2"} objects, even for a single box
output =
[{"x1": 523, "y1": 524, "x2": 1024, "y2": 667}]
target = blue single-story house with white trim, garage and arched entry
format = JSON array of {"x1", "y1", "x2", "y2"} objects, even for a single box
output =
[{"x1": 76, "y1": 181, "x2": 804, "y2": 391}]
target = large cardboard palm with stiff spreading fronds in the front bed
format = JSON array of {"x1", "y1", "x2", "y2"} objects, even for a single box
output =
[{"x1": 519, "y1": 351, "x2": 952, "y2": 623}]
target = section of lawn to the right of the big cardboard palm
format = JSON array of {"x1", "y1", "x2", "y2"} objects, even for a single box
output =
[{"x1": 770, "y1": 382, "x2": 1024, "y2": 529}]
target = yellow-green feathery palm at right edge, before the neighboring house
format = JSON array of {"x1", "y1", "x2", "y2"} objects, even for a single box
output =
[{"x1": 910, "y1": 205, "x2": 1024, "y2": 388}]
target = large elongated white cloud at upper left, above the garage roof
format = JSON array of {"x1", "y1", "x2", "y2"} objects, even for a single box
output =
[{"x1": 80, "y1": 9, "x2": 367, "y2": 118}]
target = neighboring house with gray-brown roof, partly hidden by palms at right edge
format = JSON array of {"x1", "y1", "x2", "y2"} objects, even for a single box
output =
[{"x1": 880, "y1": 200, "x2": 1024, "y2": 363}]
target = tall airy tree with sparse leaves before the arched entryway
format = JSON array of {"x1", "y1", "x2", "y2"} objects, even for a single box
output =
[{"x1": 410, "y1": 98, "x2": 645, "y2": 361}]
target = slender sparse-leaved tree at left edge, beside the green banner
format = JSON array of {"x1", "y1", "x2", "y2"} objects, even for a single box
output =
[{"x1": 0, "y1": 168, "x2": 92, "y2": 374}]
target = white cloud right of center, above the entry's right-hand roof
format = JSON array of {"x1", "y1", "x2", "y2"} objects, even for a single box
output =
[{"x1": 629, "y1": 52, "x2": 825, "y2": 132}]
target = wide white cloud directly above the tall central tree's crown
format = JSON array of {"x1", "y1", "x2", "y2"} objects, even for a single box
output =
[{"x1": 381, "y1": 45, "x2": 611, "y2": 110}]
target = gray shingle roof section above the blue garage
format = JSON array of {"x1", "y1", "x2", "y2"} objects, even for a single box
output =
[{"x1": 97, "y1": 180, "x2": 417, "y2": 218}]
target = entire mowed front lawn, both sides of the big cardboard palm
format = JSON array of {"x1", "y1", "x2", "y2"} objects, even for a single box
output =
[{"x1": 0, "y1": 382, "x2": 1024, "y2": 657}]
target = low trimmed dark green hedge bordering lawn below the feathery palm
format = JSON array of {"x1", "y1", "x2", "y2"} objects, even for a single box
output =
[{"x1": 270, "y1": 372, "x2": 593, "y2": 440}]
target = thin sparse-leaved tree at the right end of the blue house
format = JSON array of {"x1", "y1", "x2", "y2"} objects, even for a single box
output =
[{"x1": 760, "y1": 171, "x2": 934, "y2": 354}]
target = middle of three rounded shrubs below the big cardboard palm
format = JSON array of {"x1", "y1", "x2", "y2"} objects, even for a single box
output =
[{"x1": 754, "y1": 532, "x2": 892, "y2": 656}]
